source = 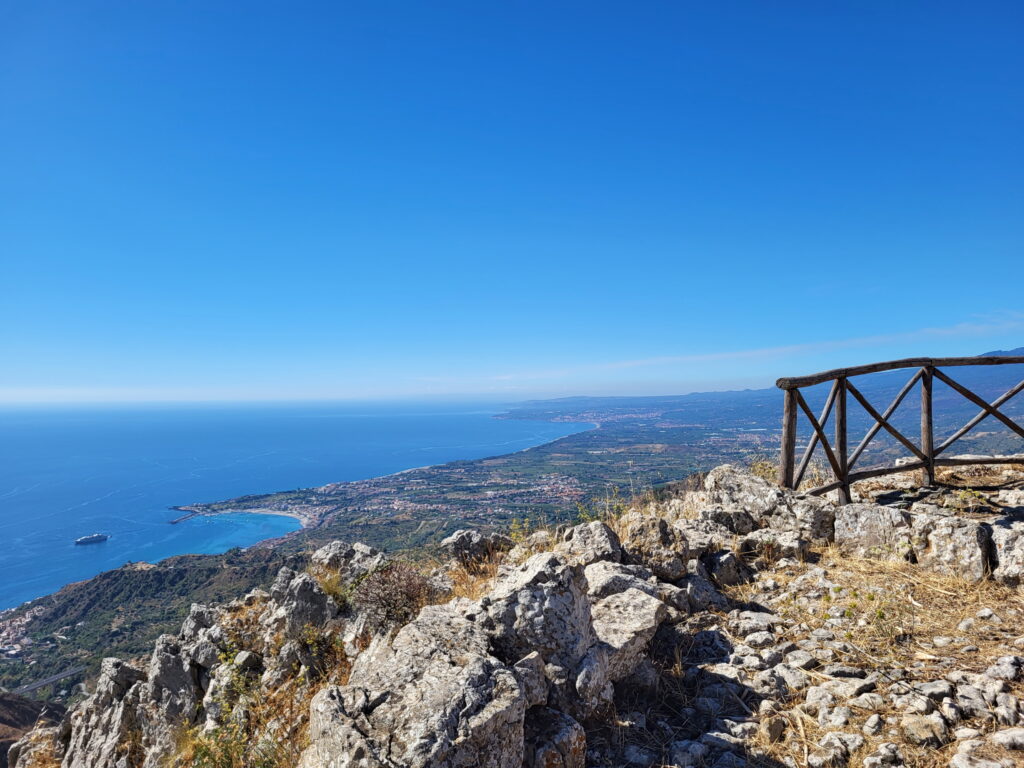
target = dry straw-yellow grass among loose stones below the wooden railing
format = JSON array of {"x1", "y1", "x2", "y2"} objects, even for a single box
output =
[{"x1": 729, "y1": 548, "x2": 1024, "y2": 768}]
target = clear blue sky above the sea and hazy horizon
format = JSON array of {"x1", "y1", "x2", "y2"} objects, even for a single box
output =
[{"x1": 0, "y1": 0, "x2": 1024, "y2": 401}]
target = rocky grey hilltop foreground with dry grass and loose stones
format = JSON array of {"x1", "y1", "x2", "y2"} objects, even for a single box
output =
[{"x1": 10, "y1": 466, "x2": 1024, "y2": 768}]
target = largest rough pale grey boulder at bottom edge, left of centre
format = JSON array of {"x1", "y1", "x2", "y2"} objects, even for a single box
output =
[{"x1": 299, "y1": 601, "x2": 526, "y2": 768}]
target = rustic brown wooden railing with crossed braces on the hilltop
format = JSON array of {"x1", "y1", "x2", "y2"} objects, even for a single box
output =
[{"x1": 775, "y1": 356, "x2": 1024, "y2": 504}]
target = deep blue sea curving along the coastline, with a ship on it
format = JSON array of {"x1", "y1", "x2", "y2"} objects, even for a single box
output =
[{"x1": 0, "y1": 403, "x2": 588, "y2": 608}]
